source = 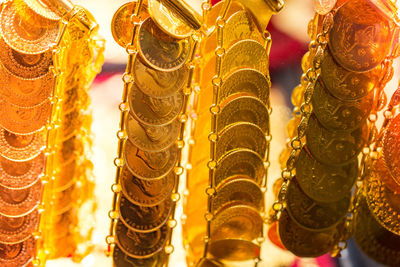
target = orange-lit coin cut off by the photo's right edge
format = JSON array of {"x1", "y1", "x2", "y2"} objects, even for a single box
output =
[{"x1": 383, "y1": 114, "x2": 400, "y2": 185}]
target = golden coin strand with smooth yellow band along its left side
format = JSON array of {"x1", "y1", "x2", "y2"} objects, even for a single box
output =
[{"x1": 183, "y1": 1, "x2": 281, "y2": 266}]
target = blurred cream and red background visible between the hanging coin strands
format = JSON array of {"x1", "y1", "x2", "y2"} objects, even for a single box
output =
[{"x1": 48, "y1": 0, "x2": 399, "y2": 267}]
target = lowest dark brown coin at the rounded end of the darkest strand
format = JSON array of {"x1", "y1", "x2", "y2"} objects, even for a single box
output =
[{"x1": 278, "y1": 211, "x2": 339, "y2": 257}]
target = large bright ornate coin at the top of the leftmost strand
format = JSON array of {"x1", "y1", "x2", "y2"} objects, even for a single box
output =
[{"x1": 0, "y1": 2, "x2": 60, "y2": 55}]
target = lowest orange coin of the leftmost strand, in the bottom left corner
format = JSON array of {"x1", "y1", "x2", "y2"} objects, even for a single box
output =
[{"x1": 0, "y1": 237, "x2": 36, "y2": 267}]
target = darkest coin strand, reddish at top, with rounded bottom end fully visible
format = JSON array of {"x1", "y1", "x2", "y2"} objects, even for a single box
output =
[{"x1": 273, "y1": 0, "x2": 395, "y2": 257}]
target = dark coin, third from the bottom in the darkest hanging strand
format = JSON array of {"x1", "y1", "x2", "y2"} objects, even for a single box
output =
[{"x1": 296, "y1": 148, "x2": 358, "y2": 203}]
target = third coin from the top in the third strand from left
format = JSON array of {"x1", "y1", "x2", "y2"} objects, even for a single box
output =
[{"x1": 219, "y1": 69, "x2": 271, "y2": 105}]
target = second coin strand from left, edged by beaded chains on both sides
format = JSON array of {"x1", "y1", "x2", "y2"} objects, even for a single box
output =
[{"x1": 107, "y1": 0, "x2": 199, "y2": 266}]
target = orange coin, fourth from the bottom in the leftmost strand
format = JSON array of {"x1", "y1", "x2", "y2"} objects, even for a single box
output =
[{"x1": 0, "y1": 154, "x2": 46, "y2": 189}]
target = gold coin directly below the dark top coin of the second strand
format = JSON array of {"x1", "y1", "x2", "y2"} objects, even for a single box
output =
[{"x1": 132, "y1": 57, "x2": 189, "y2": 98}]
